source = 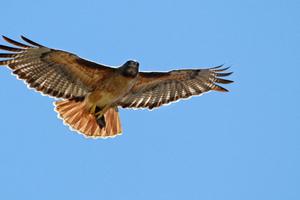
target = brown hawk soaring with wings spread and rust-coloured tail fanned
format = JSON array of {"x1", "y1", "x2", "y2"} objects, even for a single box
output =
[{"x1": 0, "y1": 36, "x2": 233, "y2": 138}]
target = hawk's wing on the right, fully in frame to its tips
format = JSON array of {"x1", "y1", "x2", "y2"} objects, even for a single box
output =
[{"x1": 119, "y1": 66, "x2": 233, "y2": 109}]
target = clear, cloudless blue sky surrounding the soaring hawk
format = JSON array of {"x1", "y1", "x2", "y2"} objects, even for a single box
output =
[{"x1": 0, "y1": 0, "x2": 300, "y2": 200}]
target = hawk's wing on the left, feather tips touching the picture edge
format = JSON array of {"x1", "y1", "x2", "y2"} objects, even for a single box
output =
[{"x1": 0, "y1": 36, "x2": 115, "y2": 99}]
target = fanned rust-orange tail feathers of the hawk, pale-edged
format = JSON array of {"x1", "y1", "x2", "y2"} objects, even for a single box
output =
[{"x1": 54, "y1": 100, "x2": 122, "y2": 138}]
